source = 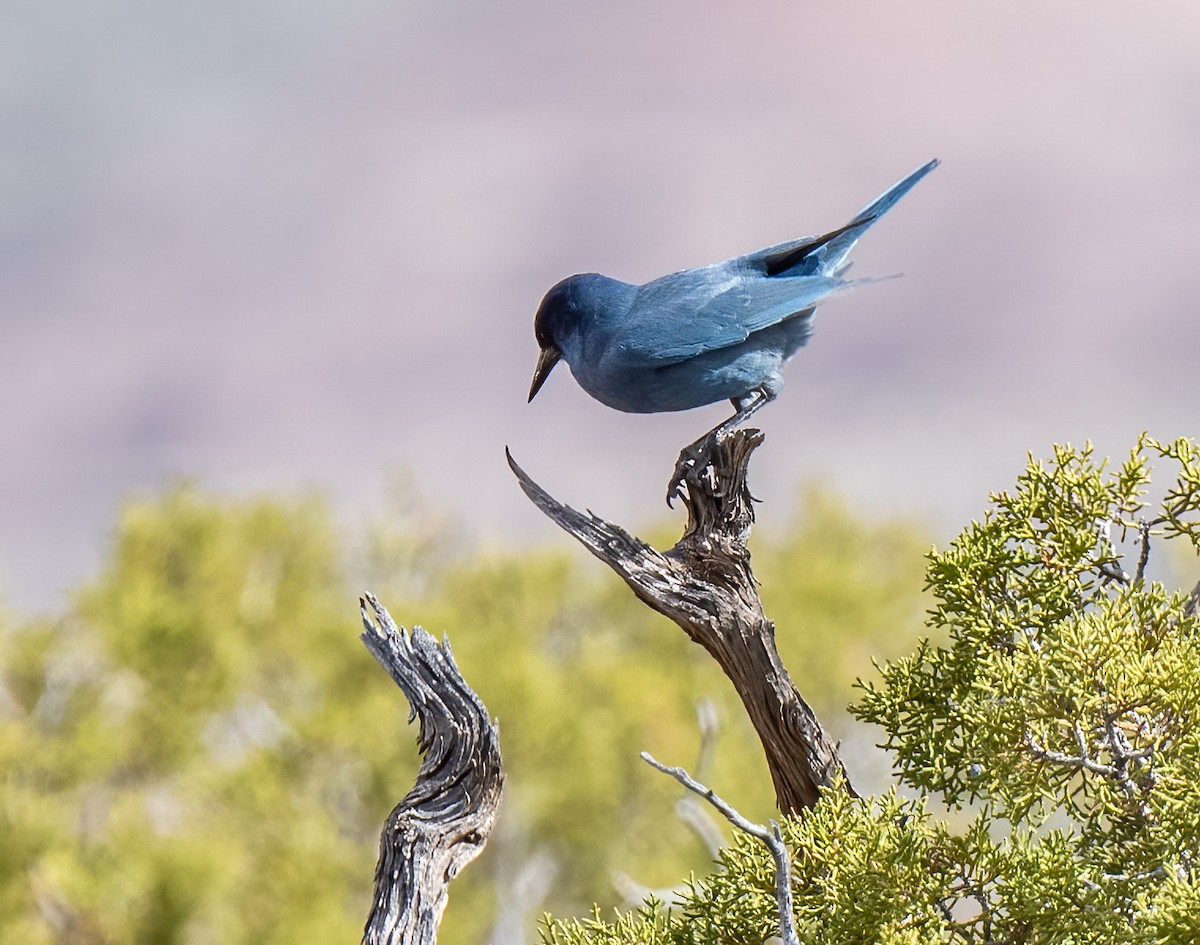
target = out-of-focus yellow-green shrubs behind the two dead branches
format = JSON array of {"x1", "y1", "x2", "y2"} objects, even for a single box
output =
[{"x1": 0, "y1": 486, "x2": 924, "y2": 945}]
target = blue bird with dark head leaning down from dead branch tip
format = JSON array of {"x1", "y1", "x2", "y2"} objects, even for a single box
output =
[{"x1": 529, "y1": 161, "x2": 938, "y2": 502}]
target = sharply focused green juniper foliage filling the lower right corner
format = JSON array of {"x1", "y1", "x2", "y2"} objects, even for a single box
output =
[{"x1": 554, "y1": 437, "x2": 1200, "y2": 945}]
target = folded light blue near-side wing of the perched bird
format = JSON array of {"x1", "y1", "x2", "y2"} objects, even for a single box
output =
[{"x1": 623, "y1": 269, "x2": 868, "y2": 366}]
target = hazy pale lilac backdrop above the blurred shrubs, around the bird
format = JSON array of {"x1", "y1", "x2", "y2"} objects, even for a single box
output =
[{"x1": 0, "y1": 0, "x2": 1200, "y2": 610}]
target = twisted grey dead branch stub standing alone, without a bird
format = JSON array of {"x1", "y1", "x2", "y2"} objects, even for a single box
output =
[{"x1": 359, "y1": 594, "x2": 504, "y2": 945}]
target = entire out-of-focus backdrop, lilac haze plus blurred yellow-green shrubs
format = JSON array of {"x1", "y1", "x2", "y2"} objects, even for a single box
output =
[{"x1": 0, "y1": 0, "x2": 1200, "y2": 943}]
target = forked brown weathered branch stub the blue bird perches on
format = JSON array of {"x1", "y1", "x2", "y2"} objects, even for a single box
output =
[{"x1": 509, "y1": 429, "x2": 853, "y2": 813}]
